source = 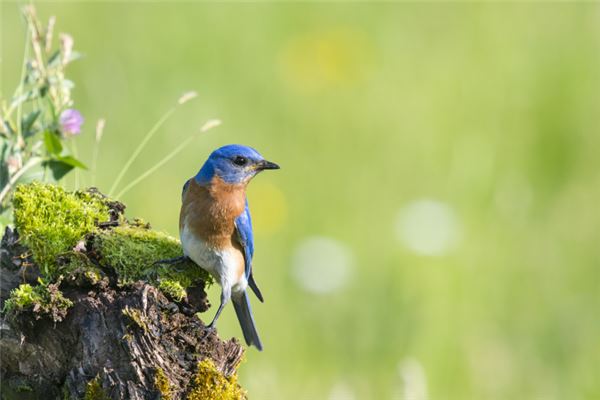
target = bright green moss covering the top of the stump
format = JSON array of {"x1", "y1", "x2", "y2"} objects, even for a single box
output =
[{"x1": 8, "y1": 183, "x2": 212, "y2": 324}]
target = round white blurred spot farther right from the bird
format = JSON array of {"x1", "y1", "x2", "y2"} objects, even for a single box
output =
[{"x1": 396, "y1": 199, "x2": 462, "y2": 256}]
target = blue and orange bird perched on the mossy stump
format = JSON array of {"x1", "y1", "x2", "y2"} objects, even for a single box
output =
[{"x1": 173, "y1": 144, "x2": 279, "y2": 351}]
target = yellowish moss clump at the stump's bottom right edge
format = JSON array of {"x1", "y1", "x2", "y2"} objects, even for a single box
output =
[{"x1": 187, "y1": 359, "x2": 246, "y2": 400}]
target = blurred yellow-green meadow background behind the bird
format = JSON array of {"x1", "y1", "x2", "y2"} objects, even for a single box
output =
[{"x1": 0, "y1": 1, "x2": 600, "y2": 400}]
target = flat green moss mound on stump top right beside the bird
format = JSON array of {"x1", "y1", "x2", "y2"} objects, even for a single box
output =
[{"x1": 93, "y1": 224, "x2": 212, "y2": 288}]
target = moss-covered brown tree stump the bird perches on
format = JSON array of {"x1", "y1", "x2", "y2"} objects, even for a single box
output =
[{"x1": 0, "y1": 184, "x2": 245, "y2": 399}]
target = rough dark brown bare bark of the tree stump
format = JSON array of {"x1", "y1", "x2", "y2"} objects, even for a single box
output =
[{"x1": 0, "y1": 229, "x2": 244, "y2": 399}]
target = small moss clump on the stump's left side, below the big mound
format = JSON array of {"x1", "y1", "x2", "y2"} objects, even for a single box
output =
[{"x1": 3, "y1": 281, "x2": 73, "y2": 322}]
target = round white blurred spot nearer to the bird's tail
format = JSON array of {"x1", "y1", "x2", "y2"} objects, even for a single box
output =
[{"x1": 292, "y1": 236, "x2": 354, "y2": 294}]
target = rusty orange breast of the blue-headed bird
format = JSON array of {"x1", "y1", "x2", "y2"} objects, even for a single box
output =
[{"x1": 179, "y1": 177, "x2": 246, "y2": 248}]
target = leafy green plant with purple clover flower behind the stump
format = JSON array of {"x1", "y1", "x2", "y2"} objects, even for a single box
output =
[{"x1": 0, "y1": 5, "x2": 87, "y2": 216}]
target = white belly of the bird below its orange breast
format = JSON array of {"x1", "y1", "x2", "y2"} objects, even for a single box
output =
[{"x1": 180, "y1": 225, "x2": 248, "y2": 292}]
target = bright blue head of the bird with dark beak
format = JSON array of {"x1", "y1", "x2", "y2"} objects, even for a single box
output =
[{"x1": 196, "y1": 144, "x2": 279, "y2": 184}]
